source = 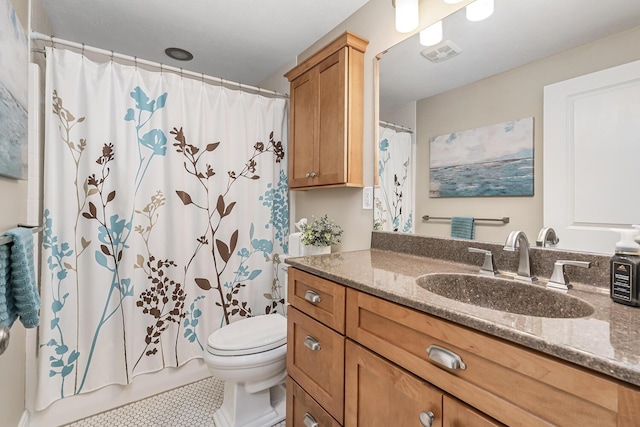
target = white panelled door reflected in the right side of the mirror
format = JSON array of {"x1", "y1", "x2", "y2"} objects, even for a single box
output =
[{"x1": 543, "y1": 61, "x2": 640, "y2": 253}]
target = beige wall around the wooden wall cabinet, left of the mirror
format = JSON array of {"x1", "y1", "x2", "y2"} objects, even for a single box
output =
[{"x1": 260, "y1": 0, "x2": 471, "y2": 251}]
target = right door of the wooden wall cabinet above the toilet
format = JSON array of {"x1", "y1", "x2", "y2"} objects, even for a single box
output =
[{"x1": 315, "y1": 48, "x2": 349, "y2": 185}]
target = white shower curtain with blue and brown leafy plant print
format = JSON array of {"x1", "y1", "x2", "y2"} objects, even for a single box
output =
[{"x1": 36, "y1": 48, "x2": 289, "y2": 409}]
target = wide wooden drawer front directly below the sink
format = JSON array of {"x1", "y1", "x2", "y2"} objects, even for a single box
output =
[{"x1": 347, "y1": 289, "x2": 638, "y2": 426}]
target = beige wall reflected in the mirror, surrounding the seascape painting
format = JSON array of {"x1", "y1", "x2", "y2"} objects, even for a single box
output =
[{"x1": 416, "y1": 27, "x2": 640, "y2": 242}]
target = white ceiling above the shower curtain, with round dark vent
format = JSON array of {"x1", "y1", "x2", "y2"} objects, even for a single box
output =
[{"x1": 42, "y1": 0, "x2": 368, "y2": 86}]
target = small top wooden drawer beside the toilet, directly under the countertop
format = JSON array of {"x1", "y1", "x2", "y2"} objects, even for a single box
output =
[{"x1": 288, "y1": 268, "x2": 345, "y2": 334}]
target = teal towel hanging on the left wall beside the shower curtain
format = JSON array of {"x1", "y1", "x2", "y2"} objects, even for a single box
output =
[{"x1": 0, "y1": 228, "x2": 40, "y2": 328}]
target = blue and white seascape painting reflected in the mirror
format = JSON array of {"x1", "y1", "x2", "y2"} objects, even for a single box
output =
[{"x1": 429, "y1": 117, "x2": 533, "y2": 197}]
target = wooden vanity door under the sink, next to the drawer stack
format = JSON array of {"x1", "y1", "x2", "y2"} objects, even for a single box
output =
[{"x1": 344, "y1": 341, "x2": 443, "y2": 427}]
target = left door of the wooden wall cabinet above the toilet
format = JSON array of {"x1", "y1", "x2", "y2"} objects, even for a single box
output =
[{"x1": 289, "y1": 68, "x2": 318, "y2": 188}]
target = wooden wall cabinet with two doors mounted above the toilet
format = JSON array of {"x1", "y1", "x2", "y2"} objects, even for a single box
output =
[{"x1": 285, "y1": 32, "x2": 369, "y2": 190}]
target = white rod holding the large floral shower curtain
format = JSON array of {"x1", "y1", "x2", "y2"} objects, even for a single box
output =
[{"x1": 31, "y1": 31, "x2": 289, "y2": 98}]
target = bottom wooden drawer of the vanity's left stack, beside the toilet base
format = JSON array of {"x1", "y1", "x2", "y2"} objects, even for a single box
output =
[{"x1": 287, "y1": 377, "x2": 340, "y2": 427}]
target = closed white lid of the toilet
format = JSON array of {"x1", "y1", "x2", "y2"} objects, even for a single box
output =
[{"x1": 207, "y1": 314, "x2": 287, "y2": 356}]
